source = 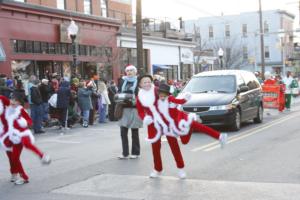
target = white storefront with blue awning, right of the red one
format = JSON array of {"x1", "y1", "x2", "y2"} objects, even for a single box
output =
[{"x1": 118, "y1": 33, "x2": 195, "y2": 80}]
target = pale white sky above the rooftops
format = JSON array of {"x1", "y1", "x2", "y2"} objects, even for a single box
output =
[{"x1": 132, "y1": 0, "x2": 299, "y2": 24}]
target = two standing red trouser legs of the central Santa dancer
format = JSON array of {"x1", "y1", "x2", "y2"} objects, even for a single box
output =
[{"x1": 152, "y1": 136, "x2": 184, "y2": 172}]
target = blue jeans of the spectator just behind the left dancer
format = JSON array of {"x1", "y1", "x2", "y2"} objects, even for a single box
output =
[{"x1": 30, "y1": 104, "x2": 43, "y2": 132}]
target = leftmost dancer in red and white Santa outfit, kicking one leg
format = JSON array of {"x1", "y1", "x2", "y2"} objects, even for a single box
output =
[{"x1": 3, "y1": 98, "x2": 51, "y2": 185}]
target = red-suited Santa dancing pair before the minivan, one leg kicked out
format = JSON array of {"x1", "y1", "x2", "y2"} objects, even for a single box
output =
[{"x1": 136, "y1": 75, "x2": 227, "y2": 178}]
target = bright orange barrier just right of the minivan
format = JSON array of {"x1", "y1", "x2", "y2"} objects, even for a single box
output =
[{"x1": 262, "y1": 84, "x2": 285, "y2": 111}]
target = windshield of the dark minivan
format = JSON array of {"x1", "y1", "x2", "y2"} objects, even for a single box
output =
[{"x1": 182, "y1": 75, "x2": 236, "y2": 93}]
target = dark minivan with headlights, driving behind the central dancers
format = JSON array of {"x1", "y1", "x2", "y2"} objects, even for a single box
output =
[{"x1": 179, "y1": 70, "x2": 263, "y2": 131}]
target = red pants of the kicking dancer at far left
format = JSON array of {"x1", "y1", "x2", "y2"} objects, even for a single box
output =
[{"x1": 6, "y1": 136, "x2": 43, "y2": 180}]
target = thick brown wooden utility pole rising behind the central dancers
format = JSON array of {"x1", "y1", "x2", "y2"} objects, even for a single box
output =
[{"x1": 136, "y1": 0, "x2": 147, "y2": 75}]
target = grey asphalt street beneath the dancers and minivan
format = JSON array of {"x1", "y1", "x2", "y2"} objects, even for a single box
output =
[{"x1": 0, "y1": 97, "x2": 300, "y2": 200}]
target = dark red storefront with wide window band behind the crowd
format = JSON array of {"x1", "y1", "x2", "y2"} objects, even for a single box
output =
[{"x1": 0, "y1": 1, "x2": 120, "y2": 80}]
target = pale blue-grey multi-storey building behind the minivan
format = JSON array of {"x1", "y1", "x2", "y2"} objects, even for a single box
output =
[{"x1": 185, "y1": 10, "x2": 295, "y2": 74}]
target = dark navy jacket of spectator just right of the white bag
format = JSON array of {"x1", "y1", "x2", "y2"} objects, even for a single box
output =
[{"x1": 57, "y1": 81, "x2": 71, "y2": 108}]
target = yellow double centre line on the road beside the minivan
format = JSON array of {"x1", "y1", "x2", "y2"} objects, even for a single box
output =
[{"x1": 191, "y1": 113, "x2": 300, "y2": 152}]
